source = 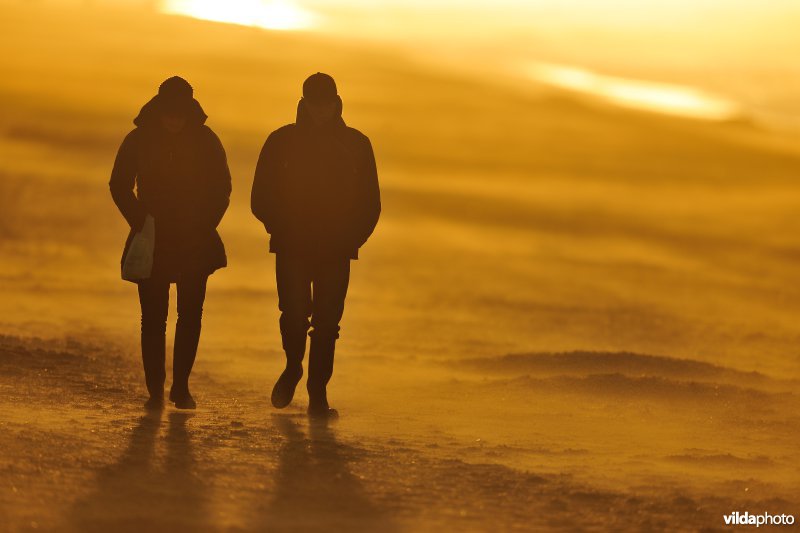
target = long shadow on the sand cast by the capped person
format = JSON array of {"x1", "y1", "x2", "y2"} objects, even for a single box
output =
[{"x1": 256, "y1": 415, "x2": 396, "y2": 532}]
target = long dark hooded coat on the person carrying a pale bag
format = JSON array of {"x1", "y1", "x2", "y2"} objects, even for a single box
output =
[{"x1": 109, "y1": 98, "x2": 231, "y2": 281}]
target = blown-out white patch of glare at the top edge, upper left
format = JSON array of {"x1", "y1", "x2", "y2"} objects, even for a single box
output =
[{"x1": 161, "y1": 0, "x2": 314, "y2": 30}]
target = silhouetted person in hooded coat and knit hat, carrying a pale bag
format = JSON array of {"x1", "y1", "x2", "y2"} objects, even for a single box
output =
[{"x1": 110, "y1": 76, "x2": 231, "y2": 409}]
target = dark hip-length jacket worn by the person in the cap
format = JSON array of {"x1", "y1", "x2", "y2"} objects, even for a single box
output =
[{"x1": 251, "y1": 100, "x2": 381, "y2": 259}]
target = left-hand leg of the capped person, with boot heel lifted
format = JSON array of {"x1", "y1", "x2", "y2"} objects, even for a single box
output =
[{"x1": 272, "y1": 254, "x2": 311, "y2": 409}]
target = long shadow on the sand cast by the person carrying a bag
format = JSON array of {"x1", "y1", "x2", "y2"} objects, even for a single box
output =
[{"x1": 67, "y1": 412, "x2": 207, "y2": 532}]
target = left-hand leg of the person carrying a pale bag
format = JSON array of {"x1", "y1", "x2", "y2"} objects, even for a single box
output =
[{"x1": 139, "y1": 279, "x2": 169, "y2": 401}]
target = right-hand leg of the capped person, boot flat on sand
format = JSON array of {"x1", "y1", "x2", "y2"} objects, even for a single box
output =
[{"x1": 307, "y1": 257, "x2": 350, "y2": 415}]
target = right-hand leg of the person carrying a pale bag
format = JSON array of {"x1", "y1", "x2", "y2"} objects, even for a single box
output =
[{"x1": 170, "y1": 274, "x2": 208, "y2": 407}]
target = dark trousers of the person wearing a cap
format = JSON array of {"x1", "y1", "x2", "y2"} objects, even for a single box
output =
[{"x1": 275, "y1": 253, "x2": 350, "y2": 401}]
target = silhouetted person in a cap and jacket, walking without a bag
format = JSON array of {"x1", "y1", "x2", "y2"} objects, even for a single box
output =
[{"x1": 251, "y1": 73, "x2": 381, "y2": 416}]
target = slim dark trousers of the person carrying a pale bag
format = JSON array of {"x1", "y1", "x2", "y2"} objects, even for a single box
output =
[{"x1": 139, "y1": 275, "x2": 208, "y2": 397}]
